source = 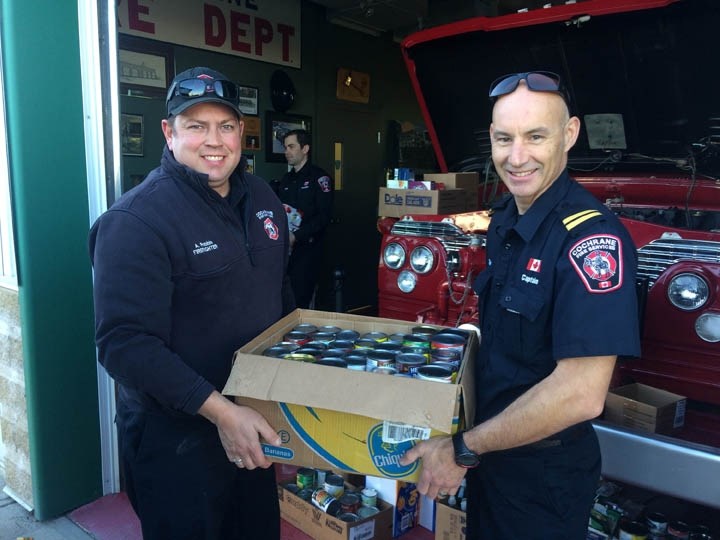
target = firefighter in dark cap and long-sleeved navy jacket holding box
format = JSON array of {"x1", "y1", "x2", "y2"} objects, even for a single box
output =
[{"x1": 90, "y1": 67, "x2": 295, "y2": 540}]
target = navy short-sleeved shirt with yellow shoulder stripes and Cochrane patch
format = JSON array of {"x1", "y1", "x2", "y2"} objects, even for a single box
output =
[{"x1": 473, "y1": 171, "x2": 640, "y2": 423}]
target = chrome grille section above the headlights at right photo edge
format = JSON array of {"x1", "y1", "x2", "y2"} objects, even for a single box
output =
[{"x1": 638, "y1": 238, "x2": 720, "y2": 287}]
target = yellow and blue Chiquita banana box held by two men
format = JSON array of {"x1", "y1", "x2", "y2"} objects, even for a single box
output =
[{"x1": 223, "y1": 309, "x2": 478, "y2": 482}]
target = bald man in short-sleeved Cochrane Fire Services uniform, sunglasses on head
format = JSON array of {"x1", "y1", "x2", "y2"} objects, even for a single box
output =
[{"x1": 402, "y1": 71, "x2": 640, "y2": 540}]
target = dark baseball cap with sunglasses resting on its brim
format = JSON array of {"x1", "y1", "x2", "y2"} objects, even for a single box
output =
[{"x1": 165, "y1": 67, "x2": 242, "y2": 118}]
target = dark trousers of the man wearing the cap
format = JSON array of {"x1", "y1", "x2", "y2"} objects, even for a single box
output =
[{"x1": 118, "y1": 413, "x2": 280, "y2": 540}]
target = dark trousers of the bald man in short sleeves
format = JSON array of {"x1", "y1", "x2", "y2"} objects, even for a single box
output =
[{"x1": 467, "y1": 424, "x2": 600, "y2": 540}]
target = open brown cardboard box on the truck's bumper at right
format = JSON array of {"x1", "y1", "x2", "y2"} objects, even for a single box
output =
[{"x1": 605, "y1": 383, "x2": 687, "y2": 434}]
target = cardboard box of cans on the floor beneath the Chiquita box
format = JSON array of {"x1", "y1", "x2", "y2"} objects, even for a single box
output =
[{"x1": 278, "y1": 484, "x2": 393, "y2": 540}]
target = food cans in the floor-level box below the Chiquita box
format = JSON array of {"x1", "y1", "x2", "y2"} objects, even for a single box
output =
[{"x1": 285, "y1": 467, "x2": 380, "y2": 523}]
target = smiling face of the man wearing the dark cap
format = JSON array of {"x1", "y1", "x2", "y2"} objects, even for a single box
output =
[{"x1": 162, "y1": 103, "x2": 243, "y2": 197}]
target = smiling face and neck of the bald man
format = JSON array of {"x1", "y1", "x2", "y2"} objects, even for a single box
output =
[{"x1": 490, "y1": 82, "x2": 580, "y2": 214}]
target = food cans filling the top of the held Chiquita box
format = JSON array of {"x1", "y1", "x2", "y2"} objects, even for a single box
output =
[{"x1": 263, "y1": 323, "x2": 469, "y2": 383}]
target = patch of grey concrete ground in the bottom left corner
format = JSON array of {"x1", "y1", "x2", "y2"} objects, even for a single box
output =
[{"x1": 0, "y1": 477, "x2": 94, "y2": 540}]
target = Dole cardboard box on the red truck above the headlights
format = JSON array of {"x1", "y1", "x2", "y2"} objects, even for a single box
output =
[{"x1": 378, "y1": 187, "x2": 466, "y2": 217}]
